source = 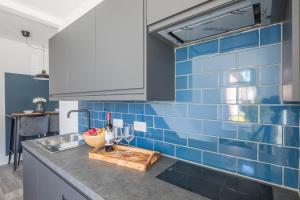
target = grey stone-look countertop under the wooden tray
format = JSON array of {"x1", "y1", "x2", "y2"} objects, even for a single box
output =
[{"x1": 23, "y1": 141, "x2": 207, "y2": 200}]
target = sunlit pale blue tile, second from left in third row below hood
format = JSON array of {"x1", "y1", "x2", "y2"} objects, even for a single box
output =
[{"x1": 189, "y1": 73, "x2": 218, "y2": 89}]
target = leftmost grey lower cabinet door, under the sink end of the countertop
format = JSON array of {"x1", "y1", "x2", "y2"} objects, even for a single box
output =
[{"x1": 23, "y1": 150, "x2": 39, "y2": 200}]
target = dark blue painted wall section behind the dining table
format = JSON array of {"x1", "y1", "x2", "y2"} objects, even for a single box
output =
[{"x1": 5, "y1": 73, "x2": 58, "y2": 154}]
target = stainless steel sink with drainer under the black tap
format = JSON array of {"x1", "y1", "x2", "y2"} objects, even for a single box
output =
[{"x1": 33, "y1": 133, "x2": 85, "y2": 153}]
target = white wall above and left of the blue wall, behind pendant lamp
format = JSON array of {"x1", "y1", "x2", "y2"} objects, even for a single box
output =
[{"x1": 0, "y1": 38, "x2": 48, "y2": 165}]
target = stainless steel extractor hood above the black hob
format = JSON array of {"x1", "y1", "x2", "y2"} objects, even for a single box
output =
[{"x1": 156, "y1": 0, "x2": 282, "y2": 46}]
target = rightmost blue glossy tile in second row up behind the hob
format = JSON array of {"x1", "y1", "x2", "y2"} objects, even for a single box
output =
[{"x1": 259, "y1": 144, "x2": 299, "y2": 168}]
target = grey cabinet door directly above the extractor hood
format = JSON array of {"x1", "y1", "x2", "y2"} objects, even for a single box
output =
[{"x1": 147, "y1": 0, "x2": 208, "y2": 25}]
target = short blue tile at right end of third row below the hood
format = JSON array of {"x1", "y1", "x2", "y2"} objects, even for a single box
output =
[{"x1": 260, "y1": 65, "x2": 280, "y2": 84}]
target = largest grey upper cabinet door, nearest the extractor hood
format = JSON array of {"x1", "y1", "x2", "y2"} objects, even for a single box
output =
[{"x1": 91, "y1": 0, "x2": 146, "y2": 91}]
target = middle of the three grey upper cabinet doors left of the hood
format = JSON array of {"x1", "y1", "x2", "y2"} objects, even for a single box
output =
[{"x1": 68, "y1": 9, "x2": 96, "y2": 93}]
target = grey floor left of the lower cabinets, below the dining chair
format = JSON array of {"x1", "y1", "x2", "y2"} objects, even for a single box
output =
[{"x1": 0, "y1": 164, "x2": 23, "y2": 200}]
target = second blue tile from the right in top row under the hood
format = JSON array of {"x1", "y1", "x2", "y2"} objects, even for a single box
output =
[{"x1": 220, "y1": 30, "x2": 259, "y2": 52}]
